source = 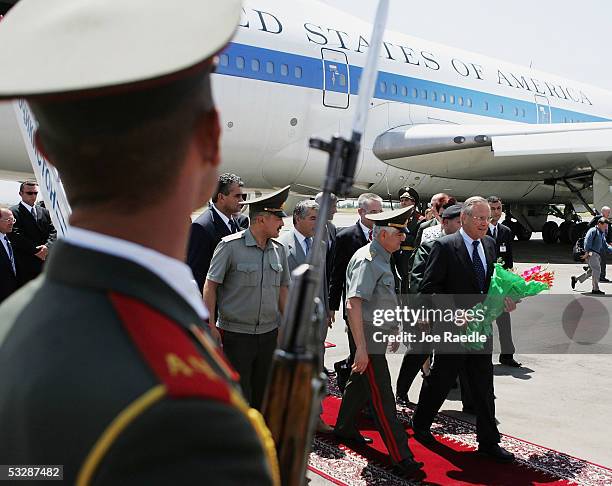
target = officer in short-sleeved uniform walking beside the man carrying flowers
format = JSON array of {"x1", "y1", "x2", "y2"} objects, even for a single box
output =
[{"x1": 334, "y1": 207, "x2": 423, "y2": 475}]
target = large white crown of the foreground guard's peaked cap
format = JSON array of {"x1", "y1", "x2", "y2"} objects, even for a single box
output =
[{"x1": 0, "y1": 0, "x2": 241, "y2": 98}]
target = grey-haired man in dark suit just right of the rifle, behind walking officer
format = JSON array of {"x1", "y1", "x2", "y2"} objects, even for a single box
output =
[{"x1": 329, "y1": 193, "x2": 382, "y2": 390}]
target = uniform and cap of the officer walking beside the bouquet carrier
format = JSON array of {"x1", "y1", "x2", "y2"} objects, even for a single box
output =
[{"x1": 335, "y1": 208, "x2": 419, "y2": 471}]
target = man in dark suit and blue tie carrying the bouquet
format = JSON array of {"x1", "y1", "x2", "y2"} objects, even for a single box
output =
[{"x1": 413, "y1": 196, "x2": 516, "y2": 462}]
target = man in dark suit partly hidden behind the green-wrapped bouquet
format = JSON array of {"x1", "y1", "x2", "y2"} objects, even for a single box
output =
[{"x1": 487, "y1": 196, "x2": 521, "y2": 368}]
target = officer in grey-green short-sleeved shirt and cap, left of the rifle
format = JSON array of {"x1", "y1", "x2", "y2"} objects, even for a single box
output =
[{"x1": 204, "y1": 186, "x2": 291, "y2": 409}]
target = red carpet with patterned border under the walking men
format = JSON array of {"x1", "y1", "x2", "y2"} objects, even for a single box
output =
[{"x1": 309, "y1": 384, "x2": 612, "y2": 486}]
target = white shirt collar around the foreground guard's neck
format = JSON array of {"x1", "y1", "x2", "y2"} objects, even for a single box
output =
[{"x1": 64, "y1": 226, "x2": 208, "y2": 319}]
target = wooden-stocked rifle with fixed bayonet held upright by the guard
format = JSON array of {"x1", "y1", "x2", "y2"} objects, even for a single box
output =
[{"x1": 262, "y1": 0, "x2": 389, "y2": 486}]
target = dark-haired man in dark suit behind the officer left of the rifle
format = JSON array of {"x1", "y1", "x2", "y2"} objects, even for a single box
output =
[{"x1": 187, "y1": 173, "x2": 248, "y2": 292}]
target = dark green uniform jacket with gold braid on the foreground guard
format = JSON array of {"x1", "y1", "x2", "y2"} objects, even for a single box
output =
[{"x1": 0, "y1": 241, "x2": 277, "y2": 486}]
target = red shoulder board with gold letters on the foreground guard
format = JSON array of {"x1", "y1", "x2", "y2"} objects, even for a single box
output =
[{"x1": 110, "y1": 292, "x2": 231, "y2": 403}]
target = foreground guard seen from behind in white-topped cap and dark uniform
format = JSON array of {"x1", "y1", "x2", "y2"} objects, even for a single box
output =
[{"x1": 0, "y1": 0, "x2": 278, "y2": 486}]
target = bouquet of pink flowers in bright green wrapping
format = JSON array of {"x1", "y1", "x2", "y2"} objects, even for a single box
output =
[{"x1": 462, "y1": 263, "x2": 554, "y2": 351}]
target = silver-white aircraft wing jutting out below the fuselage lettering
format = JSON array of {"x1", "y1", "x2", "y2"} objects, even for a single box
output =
[{"x1": 373, "y1": 122, "x2": 612, "y2": 180}]
